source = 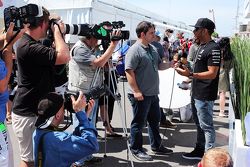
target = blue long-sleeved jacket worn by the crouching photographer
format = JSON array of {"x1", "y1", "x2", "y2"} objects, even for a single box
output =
[{"x1": 33, "y1": 111, "x2": 99, "y2": 167}]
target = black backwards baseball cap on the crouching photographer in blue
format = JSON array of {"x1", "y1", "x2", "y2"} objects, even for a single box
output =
[{"x1": 35, "y1": 92, "x2": 64, "y2": 129}]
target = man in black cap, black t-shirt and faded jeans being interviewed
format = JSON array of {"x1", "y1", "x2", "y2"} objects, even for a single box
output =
[{"x1": 176, "y1": 18, "x2": 221, "y2": 159}]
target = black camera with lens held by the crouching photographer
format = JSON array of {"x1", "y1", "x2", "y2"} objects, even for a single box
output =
[{"x1": 64, "y1": 85, "x2": 108, "y2": 113}]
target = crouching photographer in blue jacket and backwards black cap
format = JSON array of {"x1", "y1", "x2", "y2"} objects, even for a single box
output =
[{"x1": 33, "y1": 92, "x2": 99, "y2": 167}]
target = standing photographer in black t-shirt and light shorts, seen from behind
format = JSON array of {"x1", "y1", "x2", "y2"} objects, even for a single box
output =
[{"x1": 12, "y1": 6, "x2": 70, "y2": 167}]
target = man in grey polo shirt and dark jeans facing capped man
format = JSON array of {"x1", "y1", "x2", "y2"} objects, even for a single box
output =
[{"x1": 125, "y1": 21, "x2": 173, "y2": 161}]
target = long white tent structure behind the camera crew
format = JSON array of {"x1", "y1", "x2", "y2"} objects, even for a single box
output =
[{"x1": 0, "y1": 0, "x2": 191, "y2": 43}]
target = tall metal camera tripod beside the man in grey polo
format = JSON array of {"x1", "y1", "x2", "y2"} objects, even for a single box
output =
[{"x1": 97, "y1": 59, "x2": 134, "y2": 167}]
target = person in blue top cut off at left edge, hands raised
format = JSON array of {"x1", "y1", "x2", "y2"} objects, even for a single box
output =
[{"x1": 0, "y1": 23, "x2": 25, "y2": 167}]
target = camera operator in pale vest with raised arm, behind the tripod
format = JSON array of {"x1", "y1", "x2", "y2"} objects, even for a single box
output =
[{"x1": 68, "y1": 28, "x2": 121, "y2": 162}]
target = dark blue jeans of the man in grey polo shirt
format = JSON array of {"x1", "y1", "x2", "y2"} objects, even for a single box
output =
[{"x1": 128, "y1": 94, "x2": 161, "y2": 152}]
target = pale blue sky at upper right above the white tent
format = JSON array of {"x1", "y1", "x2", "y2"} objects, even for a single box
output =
[{"x1": 126, "y1": 0, "x2": 244, "y2": 36}]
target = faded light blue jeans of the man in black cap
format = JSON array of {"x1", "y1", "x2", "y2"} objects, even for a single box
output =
[{"x1": 191, "y1": 99, "x2": 215, "y2": 151}]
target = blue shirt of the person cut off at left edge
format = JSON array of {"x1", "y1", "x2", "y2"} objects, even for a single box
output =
[{"x1": 0, "y1": 59, "x2": 9, "y2": 122}]
